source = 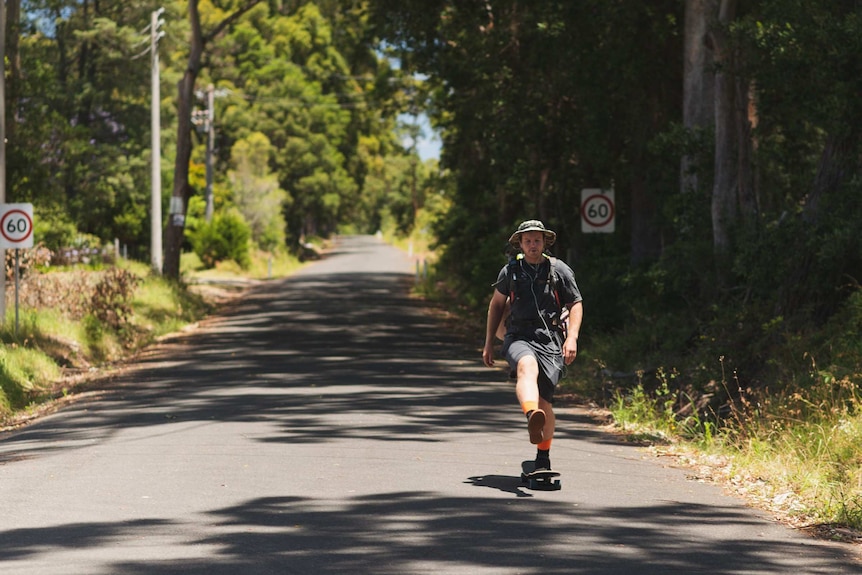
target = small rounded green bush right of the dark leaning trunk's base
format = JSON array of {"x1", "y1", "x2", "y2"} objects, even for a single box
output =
[{"x1": 190, "y1": 210, "x2": 251, "y2": 268}]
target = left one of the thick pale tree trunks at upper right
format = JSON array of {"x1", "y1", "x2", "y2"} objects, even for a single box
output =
[{"x1": 680, "y1": 0, "x2": 718, "y2": 196}]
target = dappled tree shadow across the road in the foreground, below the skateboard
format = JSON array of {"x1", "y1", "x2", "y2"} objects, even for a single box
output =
[{"x1": 0, "y1": 492, "x2": 860, "y2": 575}]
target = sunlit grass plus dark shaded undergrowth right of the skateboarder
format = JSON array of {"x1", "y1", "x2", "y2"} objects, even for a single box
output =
[{"x1": 563, "y1": 291, "x2": 862, "y2": 541}]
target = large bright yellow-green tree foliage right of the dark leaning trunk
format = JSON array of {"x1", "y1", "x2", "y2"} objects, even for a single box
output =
[{"x1": 205, "y1": 3, "x2": 398, "y2": 251}]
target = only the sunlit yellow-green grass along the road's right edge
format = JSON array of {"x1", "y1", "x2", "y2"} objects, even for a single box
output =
[{"x1": 596, "y1": 362, "x2": 862, "y2": 531}]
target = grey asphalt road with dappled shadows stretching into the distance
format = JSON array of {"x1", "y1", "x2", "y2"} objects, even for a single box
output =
[{"x1": 0, "y1": 237, "x2": 862, "y2": 575}]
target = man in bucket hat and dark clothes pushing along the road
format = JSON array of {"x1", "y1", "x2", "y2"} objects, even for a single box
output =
[{"x1": 482, "y1": 220, "x2": 583, "y2": 476}]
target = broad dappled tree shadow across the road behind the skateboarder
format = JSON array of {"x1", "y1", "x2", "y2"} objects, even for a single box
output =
[{"x1": 0, "y1": 268, "x2": 636, "y2": 458}]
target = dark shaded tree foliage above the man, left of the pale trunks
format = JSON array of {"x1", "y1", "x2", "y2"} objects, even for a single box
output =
[{"x1": 375, "y1": 1, "x2": 681, "y2": 310}]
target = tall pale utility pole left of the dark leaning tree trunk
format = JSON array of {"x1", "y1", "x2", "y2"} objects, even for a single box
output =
[{"x1": 151, "y1": 9, "x2": 165, "y2": 274}]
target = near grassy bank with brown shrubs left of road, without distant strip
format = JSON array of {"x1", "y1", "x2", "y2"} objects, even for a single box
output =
[{"x1": 0, "y1": 263, "x2": 211, "y2": 424}]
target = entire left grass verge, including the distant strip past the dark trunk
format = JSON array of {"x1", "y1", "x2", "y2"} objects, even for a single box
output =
[{"x1": 0, "y1": 252, "x2": 302, "y2": 427}]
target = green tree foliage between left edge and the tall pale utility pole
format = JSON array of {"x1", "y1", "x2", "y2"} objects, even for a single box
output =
[{"x1": 7, "y1": 2, "x2": 156, "y2": 255}]
